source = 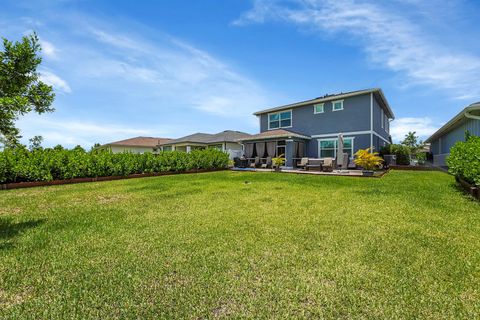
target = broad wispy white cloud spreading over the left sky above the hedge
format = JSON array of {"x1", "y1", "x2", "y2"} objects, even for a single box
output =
[{"x1": 0, "y1": 8, "x2": 272, "y2": 147}]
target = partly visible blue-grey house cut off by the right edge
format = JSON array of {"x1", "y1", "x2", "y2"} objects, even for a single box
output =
[{"x1": 425, "y1": 102, "x2": 480, "y2": 166}]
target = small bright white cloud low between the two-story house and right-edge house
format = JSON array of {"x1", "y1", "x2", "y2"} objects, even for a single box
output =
[{"x1": 390, "y1": 117, "x2": 438, "y2": 142}]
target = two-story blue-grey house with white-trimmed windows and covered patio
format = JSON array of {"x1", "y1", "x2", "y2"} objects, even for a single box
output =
[{"x1": 241, "y1": 89, "x2": 395, "y2": 167}]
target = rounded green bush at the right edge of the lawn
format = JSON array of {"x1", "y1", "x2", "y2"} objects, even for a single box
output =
[{"x1": 447, "y1": 136, "x2": 480, "y2": 186}]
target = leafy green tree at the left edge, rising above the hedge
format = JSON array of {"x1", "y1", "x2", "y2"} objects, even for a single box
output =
[{"x1": 0, "y1": 33, "x2": 55, "y2": 145}]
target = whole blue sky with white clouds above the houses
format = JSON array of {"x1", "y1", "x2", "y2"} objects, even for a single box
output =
[{"x1": 0, "y1": 0, "x2": 480, "y2": 147}]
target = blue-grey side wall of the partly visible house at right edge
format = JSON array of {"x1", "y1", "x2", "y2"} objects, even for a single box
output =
[{"x1": 430, "y1": 118, "x2": 480, "y2": 166}]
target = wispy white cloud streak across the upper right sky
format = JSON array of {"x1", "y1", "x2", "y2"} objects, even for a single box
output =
[{"x1": 233, "y1": 0, "x2": 480, "y2": 99}]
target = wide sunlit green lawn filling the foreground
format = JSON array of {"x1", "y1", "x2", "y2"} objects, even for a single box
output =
[{"x1": 0, "y1": 171, "x2": 480, "y2": 319}]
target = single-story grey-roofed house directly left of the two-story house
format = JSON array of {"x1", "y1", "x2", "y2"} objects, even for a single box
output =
[{"x1": 159, "y1": 130, "x2": 250, "y2": 159}]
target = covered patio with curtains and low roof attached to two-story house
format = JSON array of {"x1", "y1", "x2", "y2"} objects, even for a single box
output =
[{"x1": 240, "y1": 130, "x2": 311, "y2": 168}]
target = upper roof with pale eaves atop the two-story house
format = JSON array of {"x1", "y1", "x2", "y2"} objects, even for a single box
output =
[{"x1": 254, "y1": 88, "x2": 395, "y2": 119}]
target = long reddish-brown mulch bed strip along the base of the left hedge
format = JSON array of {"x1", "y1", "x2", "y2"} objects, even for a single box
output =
[{"x1": 0, "y1": 169, "x2": 226, "y2": 190}]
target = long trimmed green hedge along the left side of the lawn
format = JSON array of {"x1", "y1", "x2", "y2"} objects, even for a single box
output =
[{"x1": 0, "y1": 148, "x2": 228, "y2": 183}]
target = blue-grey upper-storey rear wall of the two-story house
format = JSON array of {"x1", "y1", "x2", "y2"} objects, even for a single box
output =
[{"x1": 260, "y1": 94, "x2": 370, "y2": 136}]
